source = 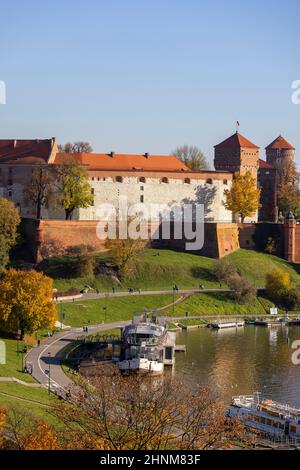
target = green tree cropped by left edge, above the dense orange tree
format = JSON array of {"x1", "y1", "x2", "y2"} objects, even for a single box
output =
[{"x1": 0, "y1": 197, "x2": 20, "y2": 272}]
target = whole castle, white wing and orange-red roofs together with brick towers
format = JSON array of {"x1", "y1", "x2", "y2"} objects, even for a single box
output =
[{"x1": 0, "y1": 132, "x2": 295, "y2": 224}]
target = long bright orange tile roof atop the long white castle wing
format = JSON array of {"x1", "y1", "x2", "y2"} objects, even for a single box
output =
[{"x1": 53, "y1": 153, "x2": 190, "y2": 171}]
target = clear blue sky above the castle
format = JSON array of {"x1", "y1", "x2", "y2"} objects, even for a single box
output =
[{"x1": 0, "y1": 0, "x2": 300, "y2": 166}]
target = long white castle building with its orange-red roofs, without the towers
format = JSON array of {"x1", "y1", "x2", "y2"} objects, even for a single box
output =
[{"x1": 0, "y1": 139, "x2": 233, "y2": 223}]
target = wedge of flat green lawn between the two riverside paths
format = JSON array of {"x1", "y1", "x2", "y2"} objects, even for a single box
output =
[{"x1": 60, "y1": 295, "x2": 178, "y2": 326}]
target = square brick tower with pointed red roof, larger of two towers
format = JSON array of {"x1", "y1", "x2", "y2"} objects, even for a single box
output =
[{"x1": 214, "y1": 132, "x2": 259, "y2": 178}]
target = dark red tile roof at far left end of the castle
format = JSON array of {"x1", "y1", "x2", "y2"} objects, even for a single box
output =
[{"x1": 0, "y1": 139, "x2": 54, "y2": 165}]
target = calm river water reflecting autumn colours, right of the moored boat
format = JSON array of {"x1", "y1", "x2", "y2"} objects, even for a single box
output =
[{"x1": 173, "y1": 325, "x2": 300, "y2": 407}]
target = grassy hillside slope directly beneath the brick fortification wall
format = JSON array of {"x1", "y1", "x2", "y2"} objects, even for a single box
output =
[{"x1": 40, "y1": 249, "x2": 300, "y2": 292}]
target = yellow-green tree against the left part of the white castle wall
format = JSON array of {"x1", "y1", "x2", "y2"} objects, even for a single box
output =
[{"x1": 56, "y1": 161, "x2": 94, "y2": 220}]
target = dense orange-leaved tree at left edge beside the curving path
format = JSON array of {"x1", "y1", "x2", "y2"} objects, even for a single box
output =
[{"x1": 0, "y1": 269, "x2": 56, "y2": 338}]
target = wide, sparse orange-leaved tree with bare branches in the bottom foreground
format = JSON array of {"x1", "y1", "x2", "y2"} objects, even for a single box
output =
[{"x1": 54, "y1": 374, "x2": 243, "y2": 450}]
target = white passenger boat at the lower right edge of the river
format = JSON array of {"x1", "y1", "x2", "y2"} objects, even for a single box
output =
[{"x1": 228, "y1": 393, "x2": 300, "y2": 442}]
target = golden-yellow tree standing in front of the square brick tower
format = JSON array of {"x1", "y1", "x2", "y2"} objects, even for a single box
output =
[{"x1": 224, "y1": 171, "x2": 260, "y2": 223}]
